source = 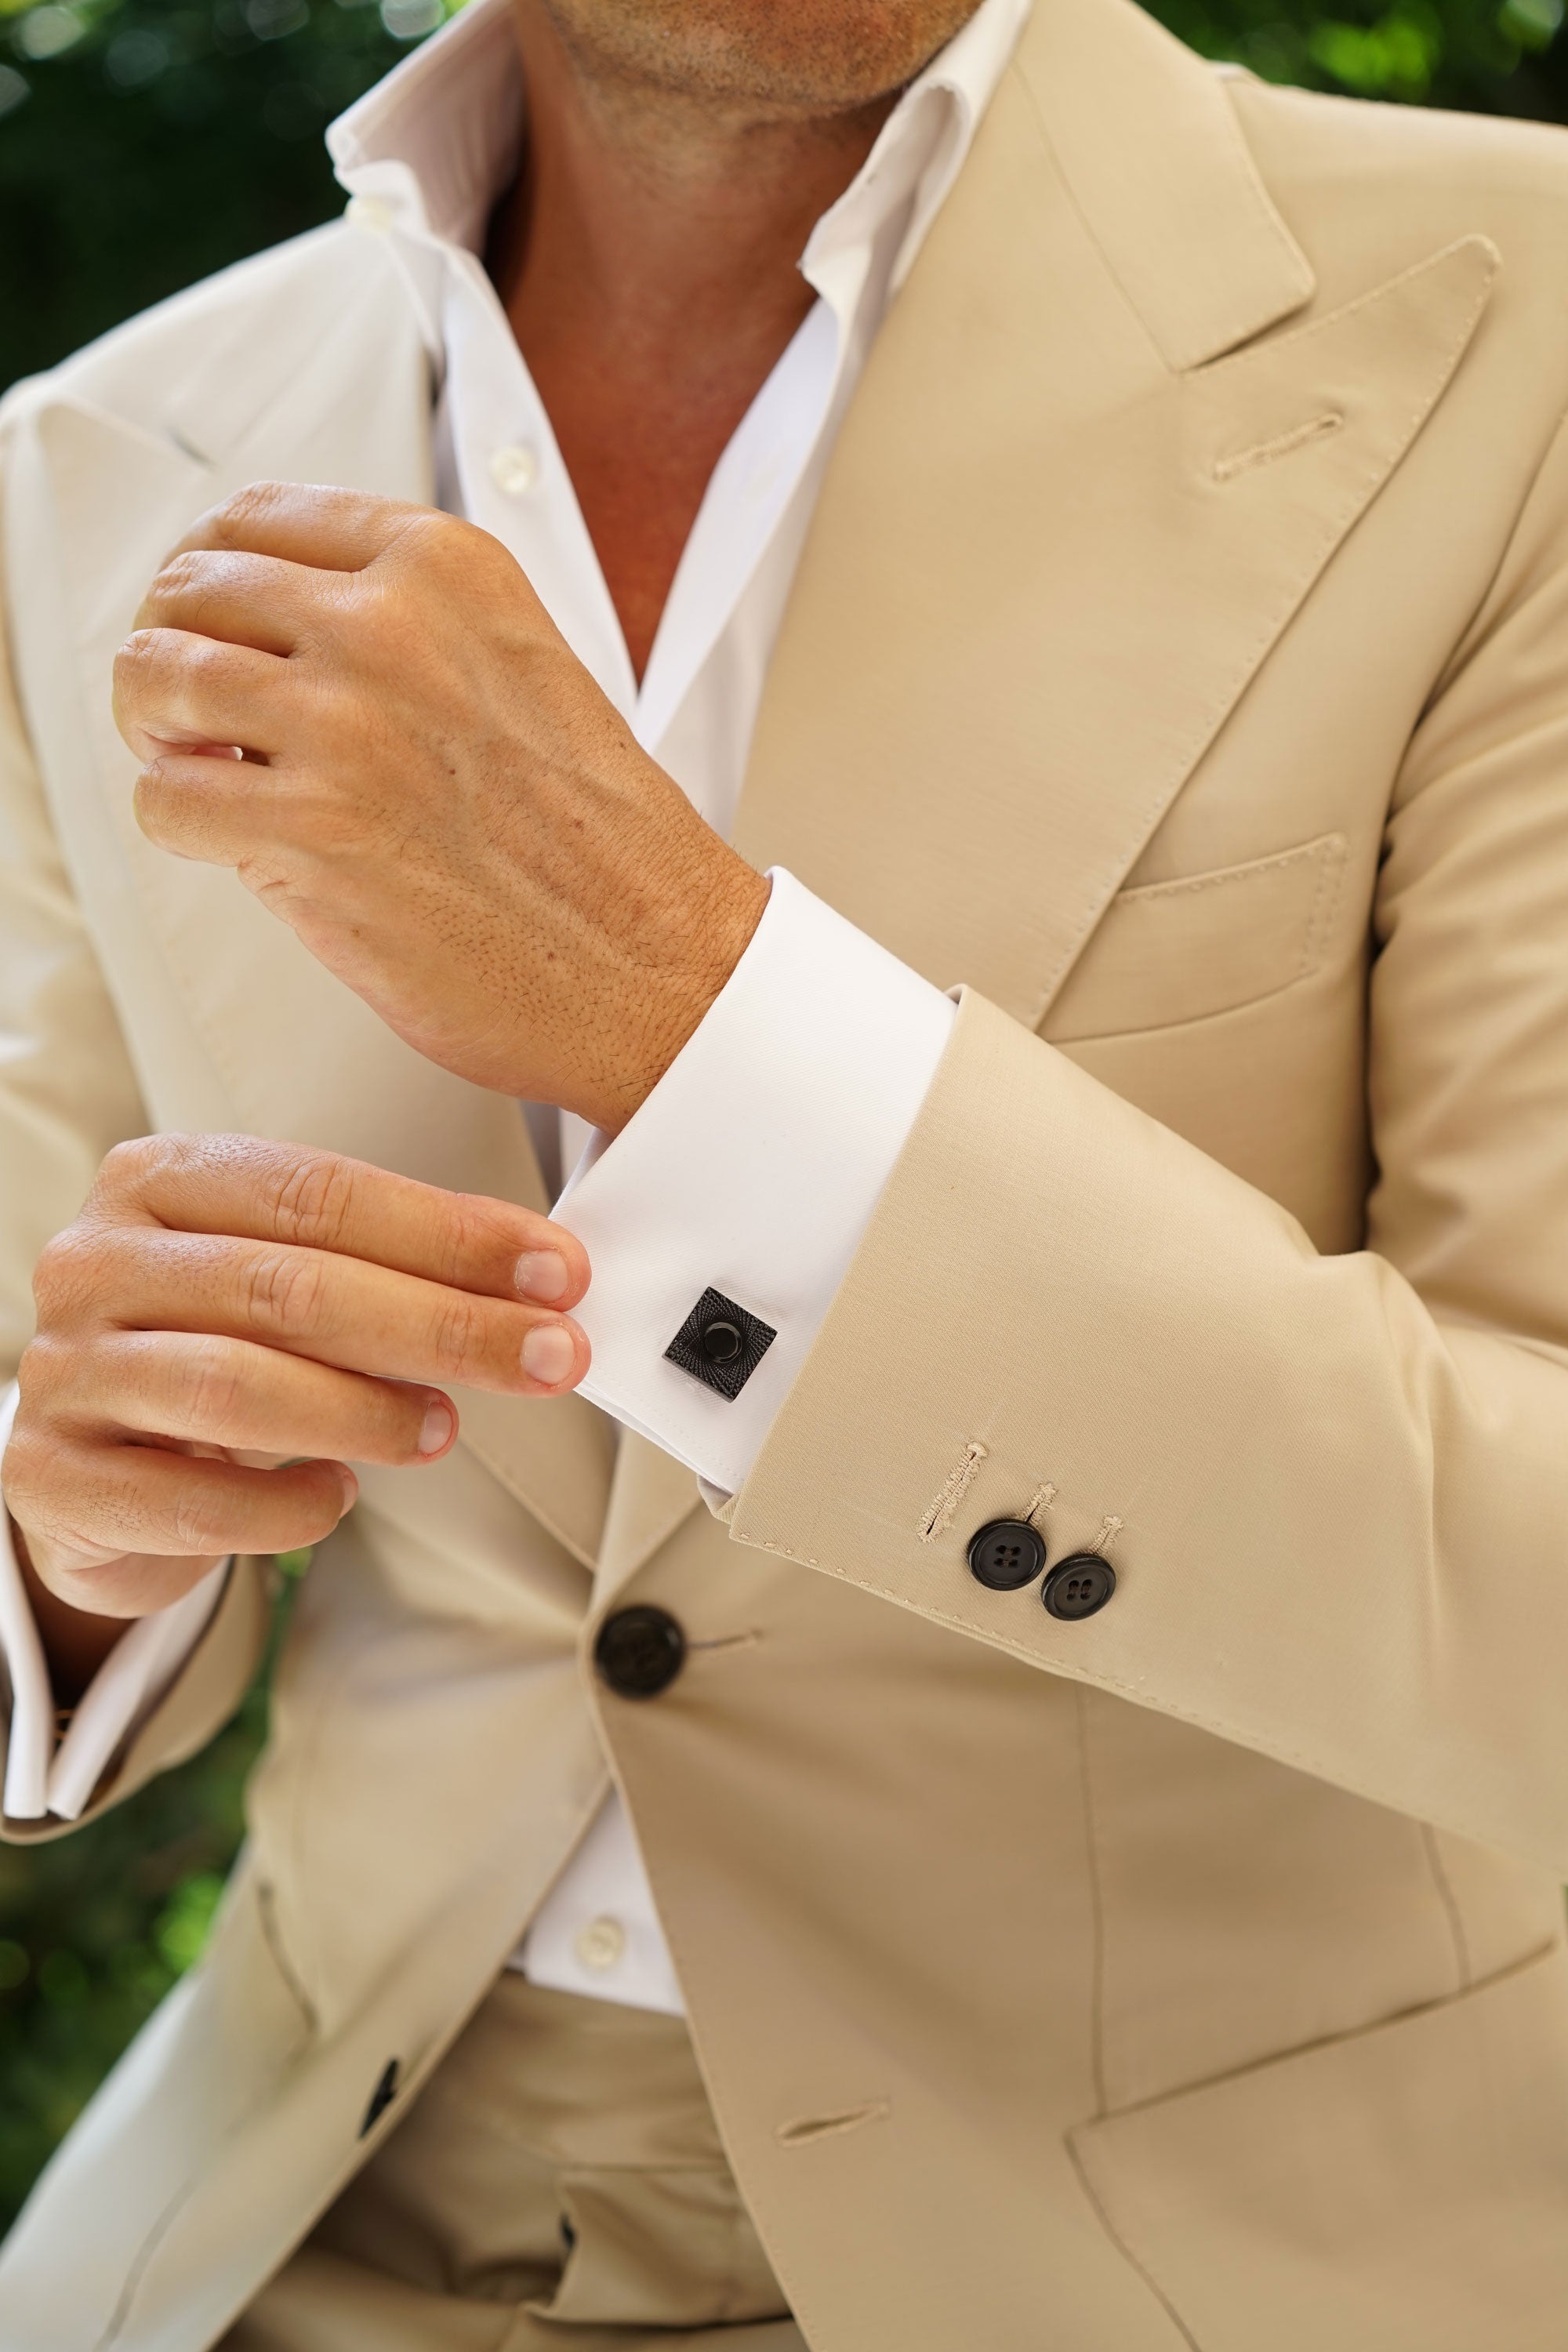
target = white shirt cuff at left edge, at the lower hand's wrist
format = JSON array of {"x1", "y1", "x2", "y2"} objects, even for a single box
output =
[{"x1": 0, "y1": 1383, "x2": 228, "y2": 1820}]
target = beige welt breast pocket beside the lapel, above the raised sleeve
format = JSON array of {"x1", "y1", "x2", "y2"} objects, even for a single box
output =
[{"x1": 1046, "y1": 833, "x2": 1345, "y2": 1044}]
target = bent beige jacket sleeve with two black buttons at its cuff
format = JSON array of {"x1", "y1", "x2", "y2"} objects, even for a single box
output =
[{"x1": 722, "y1": 400, "x2": 1568, "y2": 1875}]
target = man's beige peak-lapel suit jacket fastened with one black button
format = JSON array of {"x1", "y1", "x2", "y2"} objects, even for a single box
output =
[{"x1": 0, "y1": 0, "x2": 1568, "y2": 2352}]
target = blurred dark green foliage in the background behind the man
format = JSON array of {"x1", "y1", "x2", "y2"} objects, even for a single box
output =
[{"x1": 0, "y1": 0, "x2": 1568, "y2": 2230}]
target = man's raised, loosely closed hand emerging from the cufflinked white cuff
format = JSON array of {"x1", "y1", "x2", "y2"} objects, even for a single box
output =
[{"x1": 115, "y1": 485, "x2": 767, "y2": 1134}]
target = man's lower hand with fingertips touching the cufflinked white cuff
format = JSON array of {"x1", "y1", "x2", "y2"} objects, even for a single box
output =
[{"x1": 0, "y1": 1136, "x2": 588, "y2": 1682}]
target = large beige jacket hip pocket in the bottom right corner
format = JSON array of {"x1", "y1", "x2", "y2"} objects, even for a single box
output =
[{"x1": 1069, "y1": 1945, "x2": 1568, "y2": 2352}]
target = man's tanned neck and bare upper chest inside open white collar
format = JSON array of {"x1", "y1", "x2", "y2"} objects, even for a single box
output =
[{"x1": 489, "y1": 0, "x2": 893, "y2": 673}]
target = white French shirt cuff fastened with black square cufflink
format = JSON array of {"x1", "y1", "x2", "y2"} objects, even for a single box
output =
[{"x1": 553, "y1": 866, "x2": 954, "y2": 1494}]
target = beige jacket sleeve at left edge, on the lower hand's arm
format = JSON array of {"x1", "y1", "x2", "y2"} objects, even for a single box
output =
[{"x1": 0, "y1": 454, "x2": 266, "y2": 1839}]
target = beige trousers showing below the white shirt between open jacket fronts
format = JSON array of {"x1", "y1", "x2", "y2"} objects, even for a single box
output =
[{"x1": 221, "y1": 1973, "x2": 806, "y2": 2352}]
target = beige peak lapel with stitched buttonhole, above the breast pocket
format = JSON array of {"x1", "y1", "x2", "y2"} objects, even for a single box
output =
[{"x1": 739, "y1": 0, "x2": 1495, "y2": 1025}]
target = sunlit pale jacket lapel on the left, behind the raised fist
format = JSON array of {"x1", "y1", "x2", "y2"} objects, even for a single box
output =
[{"x1": 12, "y1": 233, "x2": 612, "y2": 1566}]
